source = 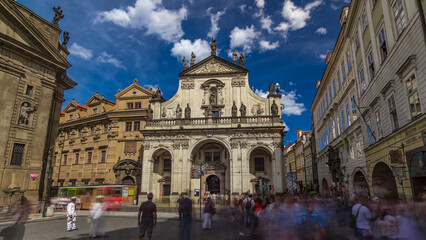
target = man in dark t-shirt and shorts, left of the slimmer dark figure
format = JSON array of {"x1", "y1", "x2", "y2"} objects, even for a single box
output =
[{"x1": 138, "y1": 193, "x2": 157, "y2": 240}]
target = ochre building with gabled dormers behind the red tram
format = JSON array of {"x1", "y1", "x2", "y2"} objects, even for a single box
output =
[{"x1": 53, "y1": 79, "x2": 162, "y2": 200}]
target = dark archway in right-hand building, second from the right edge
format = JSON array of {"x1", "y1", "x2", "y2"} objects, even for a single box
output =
[{"x1": 372, "y1": 162, "x2": 398, "y2": 199}]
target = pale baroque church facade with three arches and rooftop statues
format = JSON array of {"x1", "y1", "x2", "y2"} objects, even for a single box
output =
[{"x1": 139, "y1": 40, "x2": 285, "y2": 202}]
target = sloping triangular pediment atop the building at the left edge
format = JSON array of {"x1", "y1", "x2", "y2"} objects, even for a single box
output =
[{"x1": 0, "y1": 1, "x2": 71, "y2": 68}]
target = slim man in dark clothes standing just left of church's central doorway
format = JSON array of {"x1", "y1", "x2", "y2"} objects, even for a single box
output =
[{"x1": 179, "y1": 193, "x2": 192, "y2": 240}]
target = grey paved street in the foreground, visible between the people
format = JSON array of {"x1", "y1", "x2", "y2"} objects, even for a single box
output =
[{"x1": 0, "y1": 216, "x2": 353, "y2": 240}]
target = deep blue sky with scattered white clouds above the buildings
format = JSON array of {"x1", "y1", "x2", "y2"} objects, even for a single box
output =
[{"x1": 18, "y1": 0, "x2": 350, "y2": 144}]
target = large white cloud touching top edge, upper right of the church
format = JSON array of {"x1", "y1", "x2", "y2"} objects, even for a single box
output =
[{"x1": 275, "y1": 0, "x2": 322, "y2": 37}]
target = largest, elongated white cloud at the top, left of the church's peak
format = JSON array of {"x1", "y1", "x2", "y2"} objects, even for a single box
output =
[{"x1": 94, "y1": 0, "x2": 188, "y2": 42}]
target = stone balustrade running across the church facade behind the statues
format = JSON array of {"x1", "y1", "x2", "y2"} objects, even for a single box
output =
[{"x1": 147, "y1": 116, "x2": 281, "y2": 126}]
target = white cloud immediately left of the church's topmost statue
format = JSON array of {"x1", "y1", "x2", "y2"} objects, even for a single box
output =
[{"x1": 171, "y1": 39, "x2": 211, "y2": 63}]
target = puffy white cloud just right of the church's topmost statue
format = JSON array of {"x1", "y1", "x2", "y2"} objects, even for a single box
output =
[{"x1": 229, "y1": 25, "x2": 260, "y2": 53}]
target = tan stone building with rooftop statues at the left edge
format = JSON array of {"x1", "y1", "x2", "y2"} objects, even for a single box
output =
[{"x1": 0, "y1": 0, "x2": 76, "y2": 208}]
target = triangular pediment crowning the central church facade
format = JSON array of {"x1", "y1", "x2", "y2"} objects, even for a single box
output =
[{"x1": 179, "y1": 55, "x2": 248, "y2": 77}]
